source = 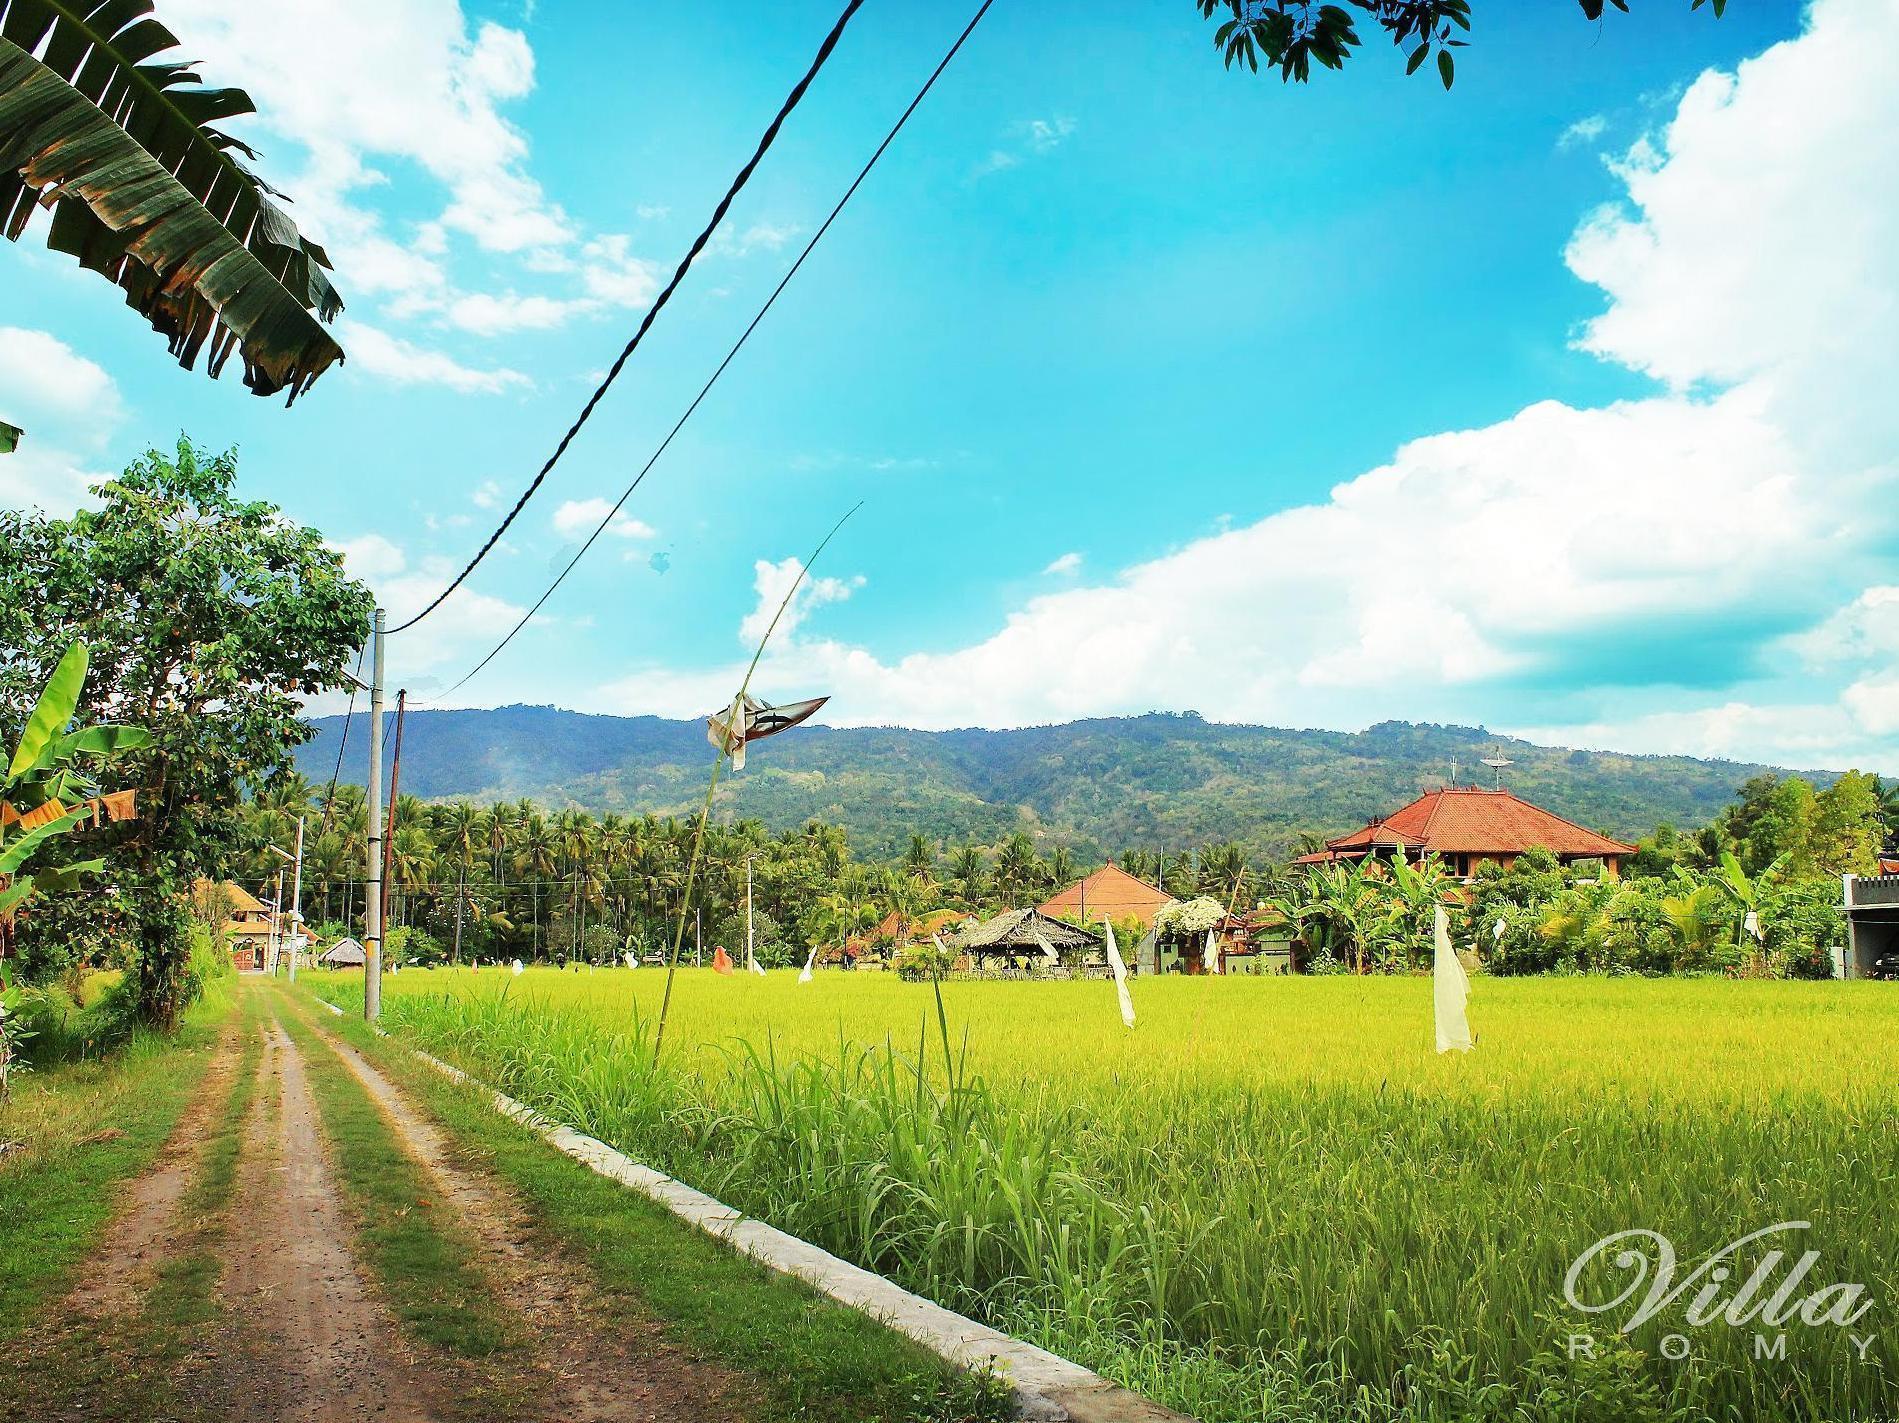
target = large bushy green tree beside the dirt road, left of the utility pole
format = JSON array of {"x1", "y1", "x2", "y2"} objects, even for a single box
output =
[{"x1": 0, "y1": 439, "x2": 372, "y2": 1026}]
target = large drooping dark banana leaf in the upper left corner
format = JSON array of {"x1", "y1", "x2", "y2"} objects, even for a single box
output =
[{"x1": 0, "y1": 0, "x2": 342, "y2": 401}]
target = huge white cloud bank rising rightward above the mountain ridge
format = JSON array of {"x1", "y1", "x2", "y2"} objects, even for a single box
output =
[{"x1": 600, "y1": 0, "x2": 1899, "y2": 768}]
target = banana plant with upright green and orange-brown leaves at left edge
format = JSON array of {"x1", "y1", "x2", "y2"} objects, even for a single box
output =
[{"x1": 0, "y1": 642, "x2": 150, "y2": 958}]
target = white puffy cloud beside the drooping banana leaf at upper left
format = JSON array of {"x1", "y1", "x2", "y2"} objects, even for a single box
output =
[{"x1": 165, "y1": 0, "x2": 651, "y2": 343}]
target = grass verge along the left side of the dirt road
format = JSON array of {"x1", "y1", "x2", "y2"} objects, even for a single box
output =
[{"x1": 0, "y1": 982, "x2": 234, "y2": 1343}]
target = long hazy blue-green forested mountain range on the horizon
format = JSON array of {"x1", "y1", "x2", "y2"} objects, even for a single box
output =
[{"x1": 284, "y1": 707, "x2": 1834, "y2": 857}]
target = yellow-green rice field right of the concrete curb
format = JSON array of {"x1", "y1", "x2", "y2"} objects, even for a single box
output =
[{"x1": 308, "y1": 969, "x2": 1899, "y2": 1423}]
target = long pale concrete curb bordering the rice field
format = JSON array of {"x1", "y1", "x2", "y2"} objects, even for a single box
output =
[{"x1": 317, "y1": 997, "x2": 1193, "y2": 1423}]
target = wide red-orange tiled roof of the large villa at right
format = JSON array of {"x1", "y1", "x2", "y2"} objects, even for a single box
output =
[{"x1": 1293, "y1": 787, "x2": 1635, "y2": 880}]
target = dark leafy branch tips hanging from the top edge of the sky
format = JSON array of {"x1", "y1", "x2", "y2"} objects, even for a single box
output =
[{"x1": 1194, "y1": 0, "x2": 1726, "y2": 89}]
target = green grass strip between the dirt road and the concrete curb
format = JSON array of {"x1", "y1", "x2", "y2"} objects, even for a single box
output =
[{"x1": 292, "y1": 997, "x2": 1012, "y2": 1423}]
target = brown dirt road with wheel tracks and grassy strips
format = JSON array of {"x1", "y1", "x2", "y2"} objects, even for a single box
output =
[{"x1": 16, "y1": 982, "x2": 752, "y2": 1423}]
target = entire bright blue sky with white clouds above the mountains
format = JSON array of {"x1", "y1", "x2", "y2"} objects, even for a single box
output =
[{"x1": 0, "y1": 0, "x2": 1899, "y2": 771}]
